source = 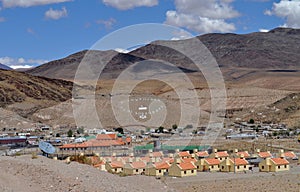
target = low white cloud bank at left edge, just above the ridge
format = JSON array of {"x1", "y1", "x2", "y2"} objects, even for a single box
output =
[{"x1": 0, "y1": 57, "x2": 48, "y2": 69}]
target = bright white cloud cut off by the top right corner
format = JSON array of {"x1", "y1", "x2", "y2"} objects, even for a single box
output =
[{"x1": 265, "y1": 0, "x2": 300, "y2": 28}]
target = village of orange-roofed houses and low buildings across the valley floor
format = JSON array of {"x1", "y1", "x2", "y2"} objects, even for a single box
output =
[{"x1": 0, "y1": 123, "x2": 299, "y2": 178}]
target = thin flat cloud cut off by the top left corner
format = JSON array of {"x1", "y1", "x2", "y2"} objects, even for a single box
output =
[{"x1": 0, "y1": 0, "x2": 72, "y2": 8}]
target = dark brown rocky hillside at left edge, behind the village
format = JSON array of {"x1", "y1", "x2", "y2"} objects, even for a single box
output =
[{"x1": 0, "y1": 70, "x2": 73, "y2": 117}]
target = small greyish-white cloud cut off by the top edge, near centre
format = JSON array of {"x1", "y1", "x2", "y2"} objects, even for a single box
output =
[{"x1": 102, "y1": 0, "x2": 158, "y2": 10}]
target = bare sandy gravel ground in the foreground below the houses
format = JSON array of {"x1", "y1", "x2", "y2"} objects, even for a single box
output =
[{"x1": 0, "y1": 155, "x2": 300, "y2": 192}]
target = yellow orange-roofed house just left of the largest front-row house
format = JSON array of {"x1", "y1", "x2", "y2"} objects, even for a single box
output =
[{"x1": 145, "y1": 162, "x2": 171, "y2": 176}]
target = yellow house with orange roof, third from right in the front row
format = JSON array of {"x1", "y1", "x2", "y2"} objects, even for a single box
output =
[{"x1": 195, "y1": 158, "x2": 221, "y2": 172}]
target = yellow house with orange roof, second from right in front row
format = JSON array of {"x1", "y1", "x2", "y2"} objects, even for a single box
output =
[{"x1": 220, "y1": 157, "x2": 250, "y2": 172}]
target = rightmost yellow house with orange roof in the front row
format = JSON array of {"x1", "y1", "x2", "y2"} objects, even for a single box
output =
[{"x1": 259, "y1": 156, "x2": 290, "y2": 172}]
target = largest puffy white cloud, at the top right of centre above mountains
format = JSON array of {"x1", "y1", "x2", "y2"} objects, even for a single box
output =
[{"x1": 165, "y1": 0, "x2": 240, "y2": 33}]
